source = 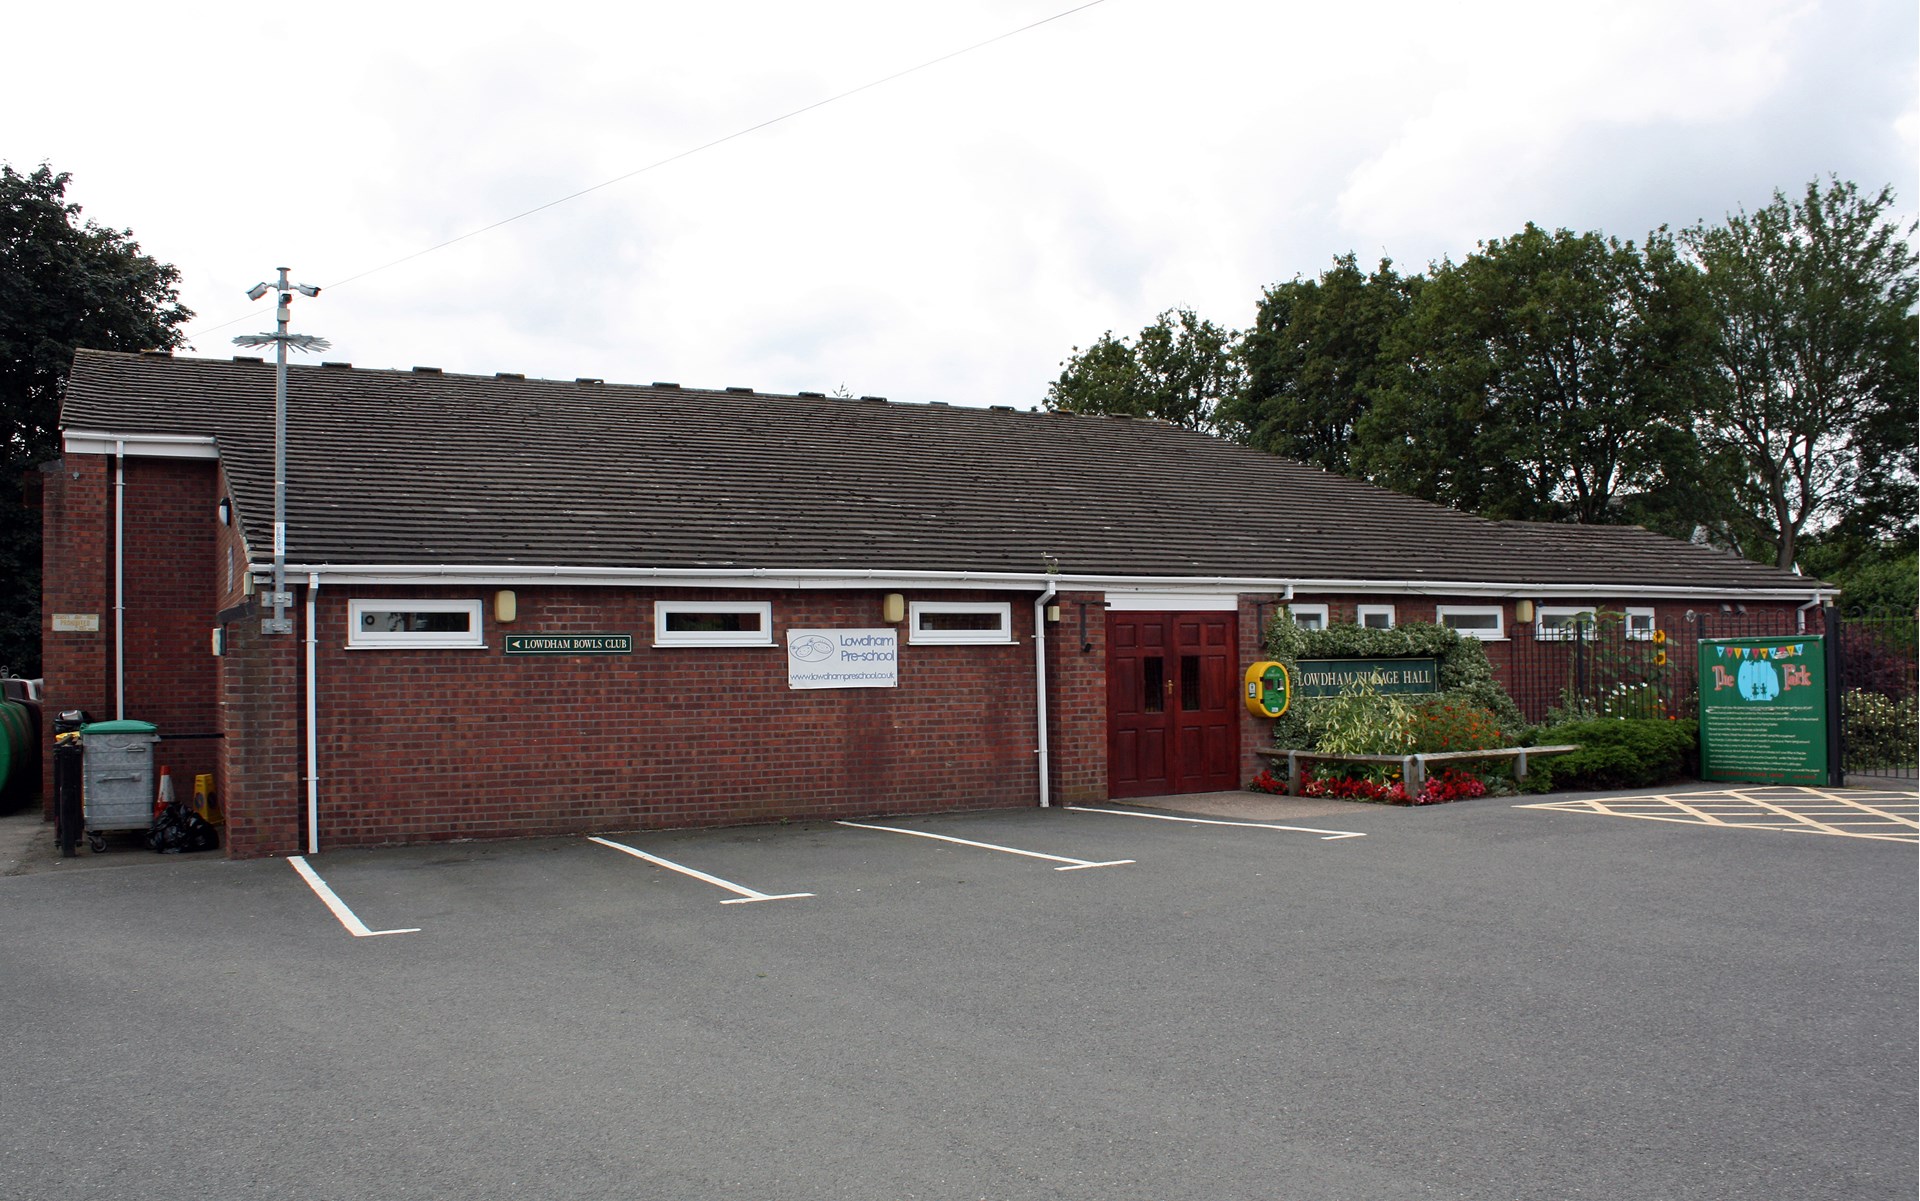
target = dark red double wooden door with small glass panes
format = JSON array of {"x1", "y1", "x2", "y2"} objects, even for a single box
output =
[{"x1": 1106, "y1": 610, "x2": 1240, "y2": 796}]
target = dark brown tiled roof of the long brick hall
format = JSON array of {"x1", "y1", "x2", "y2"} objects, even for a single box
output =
[{"x1": 61, "y1": 343, "x2": 1812, "y2": 593}]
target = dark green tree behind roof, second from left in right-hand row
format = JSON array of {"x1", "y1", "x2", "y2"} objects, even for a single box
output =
[{"x1": 1221, "y1": 253, "x2": 1419, "y2": 474}]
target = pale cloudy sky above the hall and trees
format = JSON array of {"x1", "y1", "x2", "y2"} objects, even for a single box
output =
[{"x1": 0, "y1": 0, "x2": 1920, "y2": 407}]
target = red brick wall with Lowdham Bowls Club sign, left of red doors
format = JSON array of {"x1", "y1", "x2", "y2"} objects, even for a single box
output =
[{"x1": 223, "y1": 587, "x2": 1039, "y2": 856}]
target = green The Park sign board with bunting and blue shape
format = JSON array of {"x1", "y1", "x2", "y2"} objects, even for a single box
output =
[{"x1": 1699, "y1": 637, "x2": 1830, "y2": 785}]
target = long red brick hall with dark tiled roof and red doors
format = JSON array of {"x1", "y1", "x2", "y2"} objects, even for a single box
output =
[{"x1": 44, "y1": 351, "x2": 1832, "y2": 856}]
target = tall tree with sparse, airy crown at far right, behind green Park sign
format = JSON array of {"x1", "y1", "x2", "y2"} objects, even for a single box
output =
[{"x1": 1682, "y1": 180, "x2": 1916, "y2": 568}]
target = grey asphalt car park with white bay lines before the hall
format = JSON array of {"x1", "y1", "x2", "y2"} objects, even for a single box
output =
[{"x1": 0, "y1": 800, "x2": 1916, "y2": 1201}]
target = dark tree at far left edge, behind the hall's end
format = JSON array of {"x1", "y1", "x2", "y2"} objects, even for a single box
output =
[{"x1": 0, "y1": 163, "x2": 192, "y2": 673}]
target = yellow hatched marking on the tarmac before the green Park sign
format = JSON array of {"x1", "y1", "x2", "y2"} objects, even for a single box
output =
[{"x1": 1515, "y1": 785, "x2": 1920, "y2": 842}]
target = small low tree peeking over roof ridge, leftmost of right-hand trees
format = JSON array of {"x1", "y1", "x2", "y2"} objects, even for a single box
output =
[{"x1": 1046, "y1": 309, "x2": 1246, "y2": 437}]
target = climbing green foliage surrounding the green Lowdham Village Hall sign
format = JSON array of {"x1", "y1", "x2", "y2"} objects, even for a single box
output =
[{"x1": 1267, "y1": 606, "x2": 1523, "y2": 754}]
